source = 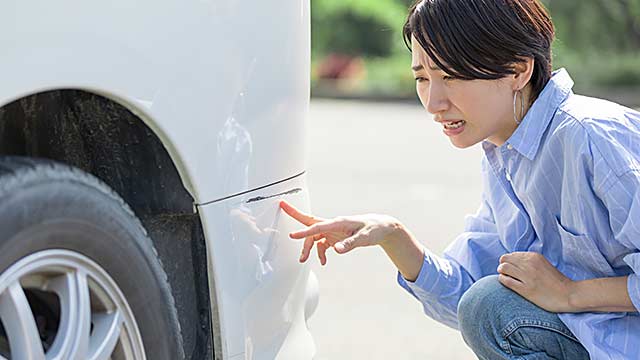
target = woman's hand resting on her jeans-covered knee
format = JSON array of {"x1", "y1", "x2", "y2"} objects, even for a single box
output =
[{"x1": 498, "y1": 252, "x2": 575, "y2": 313}]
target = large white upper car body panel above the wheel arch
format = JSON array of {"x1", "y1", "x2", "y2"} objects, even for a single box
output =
[{"x1": 0, "y1": 0, "x2": 310, "y2": 203}]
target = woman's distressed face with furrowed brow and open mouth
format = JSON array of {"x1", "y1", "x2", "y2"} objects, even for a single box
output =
[{"x1": 411, "y1": 38, "x2": 521, "y2": 148}]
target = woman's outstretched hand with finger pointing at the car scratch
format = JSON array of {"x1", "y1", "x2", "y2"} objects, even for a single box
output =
[{"x1": 280, "y1": 200, "x2": 399, "y2": 265}]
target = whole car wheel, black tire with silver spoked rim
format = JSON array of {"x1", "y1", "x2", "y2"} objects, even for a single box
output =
[{"x1": 0, "y1": 156, "x2": 185, "y2": 360}]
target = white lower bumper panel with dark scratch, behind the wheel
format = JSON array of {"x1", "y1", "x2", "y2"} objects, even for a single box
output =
[{"x1": 199, "y1": 174, "x2": 317, "y2": 360}]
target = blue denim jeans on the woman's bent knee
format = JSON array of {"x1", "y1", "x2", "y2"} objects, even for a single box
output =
[{"x1": 458, "y1": 275, "x2": 589, "y2": 360}]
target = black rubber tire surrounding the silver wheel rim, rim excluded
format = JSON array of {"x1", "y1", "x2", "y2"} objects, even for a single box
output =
[{"x1": 0, "y1": 156, "x2": 185, "y2": 360}]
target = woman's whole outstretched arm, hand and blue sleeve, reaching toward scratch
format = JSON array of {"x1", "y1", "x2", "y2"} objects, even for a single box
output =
[{"x1": 280, "y1": 197, "x2": 505, "y2": 328}]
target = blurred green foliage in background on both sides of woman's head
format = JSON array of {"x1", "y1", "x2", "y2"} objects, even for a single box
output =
[{"x1": 311, "y1": 0, "x2": 640, "y2": 97}]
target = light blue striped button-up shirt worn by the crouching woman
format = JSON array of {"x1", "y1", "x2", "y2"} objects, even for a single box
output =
[{"x1": 398, "y1": 69, "x2": 640, "y2": 359}]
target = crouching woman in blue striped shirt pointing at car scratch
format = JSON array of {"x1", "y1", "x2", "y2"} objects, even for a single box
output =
[{"x1": 281, "y1": 0, "x2": 640, "y2": 360}]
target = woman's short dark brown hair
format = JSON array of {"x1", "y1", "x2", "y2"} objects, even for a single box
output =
[{"x1": 403, "y1": 0, "x2": 555, "y2": 101}]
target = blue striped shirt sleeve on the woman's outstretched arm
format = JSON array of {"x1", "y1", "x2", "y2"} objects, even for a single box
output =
[{"x1": 397, "y1": 190, "x2": 506, "y2": 329}]
